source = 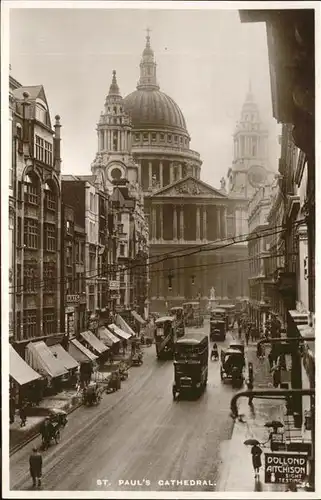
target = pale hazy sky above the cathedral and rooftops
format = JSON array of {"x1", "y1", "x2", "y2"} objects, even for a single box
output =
[{"x1": 9, "y1": 2, "x2": 279, "y2": 186}]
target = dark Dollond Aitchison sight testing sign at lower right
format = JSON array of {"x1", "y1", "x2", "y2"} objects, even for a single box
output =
[{"x1": 264, "y1": 452, "x2": 308, "y2": 484}]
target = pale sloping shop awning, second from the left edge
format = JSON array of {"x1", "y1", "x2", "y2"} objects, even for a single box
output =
[{"x1": 26, "y1": 341, "x2": 68, "y2": 378}]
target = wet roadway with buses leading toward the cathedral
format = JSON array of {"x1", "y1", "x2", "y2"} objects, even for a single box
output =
[{"x1": 10, "y1": 323, "x2": 234, "y2": 491}]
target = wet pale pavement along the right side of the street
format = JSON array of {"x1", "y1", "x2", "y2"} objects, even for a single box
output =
[{"x1": 216, "y1": 344, "x2": 285, "y2": 493}]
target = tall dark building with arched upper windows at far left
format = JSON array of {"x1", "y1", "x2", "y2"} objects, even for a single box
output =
[{"x1": 9, "y1": 77, "x2": 61, "y2": 357}]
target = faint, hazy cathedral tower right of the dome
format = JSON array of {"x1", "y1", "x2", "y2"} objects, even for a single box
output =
[{"x1": 227, "y1": 83, "x2": 274, "y2": 199}]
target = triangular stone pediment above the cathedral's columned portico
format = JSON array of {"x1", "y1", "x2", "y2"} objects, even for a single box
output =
[{"x1": 151, "y1": 176, "x2": 227, "y2": 198}]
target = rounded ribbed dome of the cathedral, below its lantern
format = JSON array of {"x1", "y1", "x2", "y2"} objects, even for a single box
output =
[{"x1": 124, "y1": 88, "x2": 187, "y2": 133}]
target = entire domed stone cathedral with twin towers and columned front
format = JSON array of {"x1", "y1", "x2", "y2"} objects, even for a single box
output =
[{"x1": 92, "y1": 35, "x2": 274, "y2": 312}]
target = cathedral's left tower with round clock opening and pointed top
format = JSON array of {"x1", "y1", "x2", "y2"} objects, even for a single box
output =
[{"x1": 91, "y1": 71, "x2": 138, "y2": 193}]
